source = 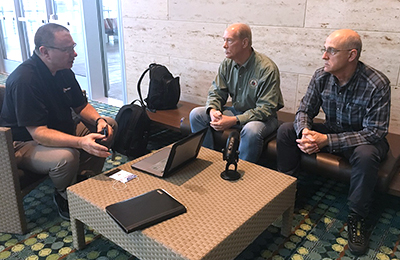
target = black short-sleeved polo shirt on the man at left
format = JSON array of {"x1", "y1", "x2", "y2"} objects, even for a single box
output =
[{"x1": 0, "y1": 53, "x2": 87, "y2": 141}]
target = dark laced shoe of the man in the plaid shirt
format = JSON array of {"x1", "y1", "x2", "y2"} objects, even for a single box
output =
[{"x1": 347, "y1": 212, "x2": 371, "y2": 256}]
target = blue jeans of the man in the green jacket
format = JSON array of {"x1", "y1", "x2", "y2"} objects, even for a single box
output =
[{"x1": 189, "y1": 107, "x2": 278, "y2": 163}]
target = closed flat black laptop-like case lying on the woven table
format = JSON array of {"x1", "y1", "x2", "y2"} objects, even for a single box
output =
[{"x1": 106, "y1": 189, "x2": 186, "y2": 233}]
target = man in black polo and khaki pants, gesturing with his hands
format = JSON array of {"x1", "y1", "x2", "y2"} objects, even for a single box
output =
[{"x1": 0, "y1": 23, "x2": 117, "y2": 219}]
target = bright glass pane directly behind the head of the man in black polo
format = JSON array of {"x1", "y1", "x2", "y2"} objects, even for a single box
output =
[{"x1": 52, "y1": 0, "x2": 86, "y2": 77}]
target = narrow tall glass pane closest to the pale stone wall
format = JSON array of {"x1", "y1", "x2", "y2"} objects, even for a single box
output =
[{"x1": 103, "y1": 0, "x2": 123, "y2": 100}]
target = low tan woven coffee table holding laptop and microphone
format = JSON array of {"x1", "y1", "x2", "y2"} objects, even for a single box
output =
[{"x1": 68, "y1": 147, "x2": 296, "y2": 260}]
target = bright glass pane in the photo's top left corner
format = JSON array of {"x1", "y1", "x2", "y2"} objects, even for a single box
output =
[{"x1": 0, "y1": 0, "x2": 22, "y2": 62}]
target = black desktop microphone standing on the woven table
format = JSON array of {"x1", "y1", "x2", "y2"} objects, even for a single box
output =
[{"x1": 221, "y1": 131, "x2": 241, "y2": 181}]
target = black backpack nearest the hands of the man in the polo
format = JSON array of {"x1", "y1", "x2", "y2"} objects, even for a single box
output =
[{"x1": 112, "y1": 99, "x2": 151, "y2": 159}]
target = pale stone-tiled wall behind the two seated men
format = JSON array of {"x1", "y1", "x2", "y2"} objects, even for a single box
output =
[{"x1": 122, "y1": 0, "x2": 400, "y2": 134}]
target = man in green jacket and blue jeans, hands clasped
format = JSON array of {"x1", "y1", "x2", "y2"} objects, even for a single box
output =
[{"x1": 189, "y1": 24, "x2": 283, "y2": 162}]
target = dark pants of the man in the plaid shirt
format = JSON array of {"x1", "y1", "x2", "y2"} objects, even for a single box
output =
[{"x1": 277, "y1": 123, "x2": 389, "y2": 217}]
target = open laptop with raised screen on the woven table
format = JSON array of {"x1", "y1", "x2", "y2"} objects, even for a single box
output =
[{"x1": 132, "y1": 128, "x2": 208, "y2": 178}]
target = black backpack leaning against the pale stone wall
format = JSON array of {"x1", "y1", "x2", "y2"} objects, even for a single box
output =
[{"x1": 138, "y1": 63, "x2": 181, "y2": 112}]
